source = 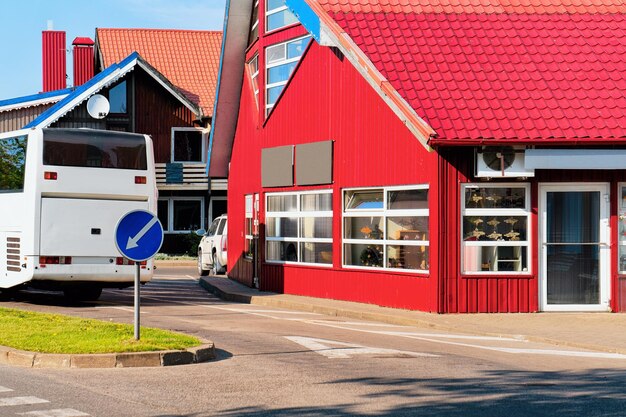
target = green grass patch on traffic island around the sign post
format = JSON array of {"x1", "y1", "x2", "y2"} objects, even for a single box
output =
[{"x1": 0, "y1": 308, "x2": 200, "y2": 353}]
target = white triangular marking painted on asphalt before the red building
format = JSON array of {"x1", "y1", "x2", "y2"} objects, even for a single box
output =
[{"x1": 285, "y1": 336, "x2": 439, "y2": 359}]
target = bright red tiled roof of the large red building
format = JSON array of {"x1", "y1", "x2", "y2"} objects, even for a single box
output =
[{"x1": 317, "y1": 0, "x2": 626, "y2": 140}]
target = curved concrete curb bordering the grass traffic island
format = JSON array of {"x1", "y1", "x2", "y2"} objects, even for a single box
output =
[{"x1": 0, "y1": 341, "x2": 215, "y2": 368}]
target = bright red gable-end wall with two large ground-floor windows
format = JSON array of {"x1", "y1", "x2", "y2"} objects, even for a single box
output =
[{"x1": 228, "y1": 43, "x2": 438, "y2": 311}]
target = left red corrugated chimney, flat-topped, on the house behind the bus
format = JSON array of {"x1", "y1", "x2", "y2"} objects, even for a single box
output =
[{"x1": 41, "y1": 30, "x2": 66, "y2": 92}]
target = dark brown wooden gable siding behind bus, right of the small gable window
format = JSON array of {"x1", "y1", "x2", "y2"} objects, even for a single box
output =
[{"x1": 134, "y1": 71, "x2": 196, "y2": 162}]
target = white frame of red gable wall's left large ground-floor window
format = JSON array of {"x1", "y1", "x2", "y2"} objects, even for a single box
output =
[{"x1": 265, "y1": 189, "x2": 334, "y2": 268}]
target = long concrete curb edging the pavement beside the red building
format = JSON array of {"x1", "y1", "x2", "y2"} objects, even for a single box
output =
[{"x1": 200, "y1": 278, "x2": 626, "y2": 355}]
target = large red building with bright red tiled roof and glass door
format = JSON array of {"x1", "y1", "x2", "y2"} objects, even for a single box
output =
[{"x1": 209, "y1": 0, "x2": 626, "y2": 313}]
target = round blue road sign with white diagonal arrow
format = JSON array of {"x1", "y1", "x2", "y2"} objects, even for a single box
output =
[{"x1": 115, "y1": 210, "x2": 163, "y2": 262}]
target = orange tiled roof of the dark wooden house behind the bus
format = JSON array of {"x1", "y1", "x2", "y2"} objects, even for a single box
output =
[{"x1": 96, "y1": 28, "x2": 222, "y2": 116}]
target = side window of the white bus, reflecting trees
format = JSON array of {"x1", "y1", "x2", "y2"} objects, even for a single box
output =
[{"x1": 0, "y1": 136, "x2": 28, "y2": 193}]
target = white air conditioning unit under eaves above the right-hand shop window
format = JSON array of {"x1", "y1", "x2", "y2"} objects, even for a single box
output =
[{"x1": 475, "y1": 146, "x2": 535, "y2": 178}]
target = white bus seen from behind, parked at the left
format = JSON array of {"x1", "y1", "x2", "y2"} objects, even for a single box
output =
[{"x1": 0, "y1": 129, "x2": 157, "y2": 300}]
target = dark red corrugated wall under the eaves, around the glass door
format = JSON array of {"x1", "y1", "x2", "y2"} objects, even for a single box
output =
[{"x1": 439, "y1": 148, "x2": 626, "y2": 313}]
